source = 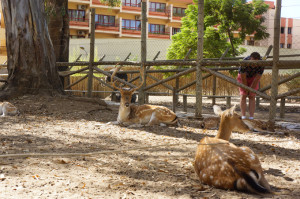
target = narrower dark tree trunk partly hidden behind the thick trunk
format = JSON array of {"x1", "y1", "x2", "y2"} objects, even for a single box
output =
[{"x1": 46, "y1": 0, "x2": 70, "y2": 85}]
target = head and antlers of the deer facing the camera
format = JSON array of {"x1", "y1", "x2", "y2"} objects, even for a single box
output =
[{"x1": 111, "y1": 66, "x2": 144, "y2": 107}]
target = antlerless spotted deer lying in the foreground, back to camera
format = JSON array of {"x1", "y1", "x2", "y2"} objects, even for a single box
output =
[{"x1": 194, "y1": 105, "x2": 271, "y2": 193}]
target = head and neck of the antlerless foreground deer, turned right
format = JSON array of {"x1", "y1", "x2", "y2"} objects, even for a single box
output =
[{"x1": 213, "y1": 105, "x2": 250, "y2": 140}]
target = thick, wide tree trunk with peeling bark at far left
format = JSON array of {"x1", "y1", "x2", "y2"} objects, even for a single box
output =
[{"x1": 0, "y1": 0, "x2": 63, "y2": 99}]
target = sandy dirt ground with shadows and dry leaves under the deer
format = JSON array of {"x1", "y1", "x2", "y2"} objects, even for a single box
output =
[{"x1": 0, "y1": 96, "x2": 300, "y2": 199}]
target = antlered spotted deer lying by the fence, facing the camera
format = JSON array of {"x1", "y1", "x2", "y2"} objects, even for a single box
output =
[{"x1": 111, "y1": 66, "x2": 179, "y2": 126}]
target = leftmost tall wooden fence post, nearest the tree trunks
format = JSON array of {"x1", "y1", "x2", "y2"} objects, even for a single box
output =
[{"x1": 88, "y1": 8, "x2": 95, "y2": 97}]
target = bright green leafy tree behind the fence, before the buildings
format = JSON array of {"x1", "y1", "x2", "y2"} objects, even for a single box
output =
[{"x1": 167, "y1": 0, "x2": 269, "y2": 59}]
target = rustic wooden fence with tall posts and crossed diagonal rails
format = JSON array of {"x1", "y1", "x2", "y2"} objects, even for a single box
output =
[{"x1": 0, "y1": 0, "x2": 300, "y2": 128}]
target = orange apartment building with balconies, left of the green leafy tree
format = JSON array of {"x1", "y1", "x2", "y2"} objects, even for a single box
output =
[{"x1": 69, "y1": 0, "x2": 193, "y2": 39}]
